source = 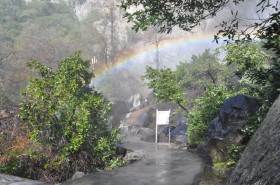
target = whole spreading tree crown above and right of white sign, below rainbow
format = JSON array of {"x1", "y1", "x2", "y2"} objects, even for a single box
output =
[{"x1": 142, "y1": 49, "x2": 233, "y2": 111}]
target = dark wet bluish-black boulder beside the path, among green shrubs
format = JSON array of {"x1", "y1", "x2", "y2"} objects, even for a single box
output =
[{"x1": 207, "y1": 95, "x2": 259, "y2": 161}]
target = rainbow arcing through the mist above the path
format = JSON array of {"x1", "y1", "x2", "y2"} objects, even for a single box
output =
[{"x1": 94, "y1": 33, "x2": 218, "y2": 81}]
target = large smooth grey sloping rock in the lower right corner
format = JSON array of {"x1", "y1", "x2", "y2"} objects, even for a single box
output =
[{"x1": 227, "y1": 97, "x2": 280, "y2": 185}]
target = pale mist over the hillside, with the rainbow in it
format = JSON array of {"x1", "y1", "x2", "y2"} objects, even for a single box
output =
[{"x1": 0, "y1": 0, "x2": 270, "y2": 102}]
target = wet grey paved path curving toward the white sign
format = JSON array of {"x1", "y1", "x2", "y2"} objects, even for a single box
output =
[{"x1": 61, "y1": 138, "x2": 202, "y2": 185}]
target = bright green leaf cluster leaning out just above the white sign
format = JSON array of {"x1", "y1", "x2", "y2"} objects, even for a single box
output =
[{"x1": 142, "y1": 67, "x2": 187, "y2": 110}]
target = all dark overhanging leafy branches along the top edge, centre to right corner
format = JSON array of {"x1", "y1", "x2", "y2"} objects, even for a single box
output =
[{"x1": 121, "y1": 0, "x2": 280, "y2": 39}]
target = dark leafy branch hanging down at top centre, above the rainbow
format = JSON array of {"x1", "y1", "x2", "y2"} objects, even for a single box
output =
[{"x1": 121, "y1": 0, "x2": 234, "y2": 33}]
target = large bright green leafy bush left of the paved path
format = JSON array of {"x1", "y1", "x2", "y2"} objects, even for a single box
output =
[{"x1": 19, "y1": 53, "x2": 121, "y2": 181}]
